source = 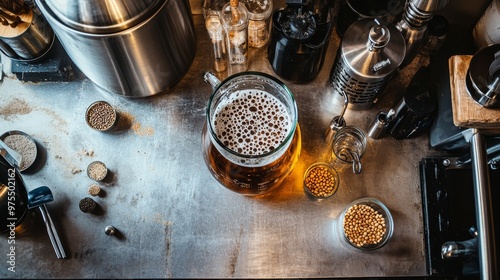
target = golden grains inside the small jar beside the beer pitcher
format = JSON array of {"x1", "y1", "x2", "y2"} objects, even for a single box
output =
[{"x1": 304, "y1": 166, "x2": 336, "y2": 197}]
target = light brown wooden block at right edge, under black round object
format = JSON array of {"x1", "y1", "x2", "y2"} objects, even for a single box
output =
[{"x1": 448, "y1": 55, "x2": 500, "y2": 129}]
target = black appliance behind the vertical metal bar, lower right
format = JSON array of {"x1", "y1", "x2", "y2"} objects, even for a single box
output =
[{"x1": 420, "y1": 157, "x2": 500, "y2": 279}]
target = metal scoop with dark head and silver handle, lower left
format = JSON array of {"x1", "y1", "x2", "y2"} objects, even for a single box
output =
[{"x1": 28, "y1": 186, "x2": 66, "y2": 259}]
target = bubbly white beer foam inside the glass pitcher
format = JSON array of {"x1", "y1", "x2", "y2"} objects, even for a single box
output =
[{"x1": 212, "y1": 90, "x2": 292, "y2": 156}]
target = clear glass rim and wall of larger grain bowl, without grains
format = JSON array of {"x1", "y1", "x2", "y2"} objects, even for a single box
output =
[{"x1": 337, "y1": 197, "x2": 394, "y2": 251}]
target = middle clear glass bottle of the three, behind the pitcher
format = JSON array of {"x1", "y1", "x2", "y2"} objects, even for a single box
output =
[{"x1": 221, "y1": 0, "x2": 248, "y2": 75}]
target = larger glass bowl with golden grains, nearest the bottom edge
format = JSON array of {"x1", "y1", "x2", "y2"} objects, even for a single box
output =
[{"x1": 338, "y1": 197, "x2": 394, "y2": 251}]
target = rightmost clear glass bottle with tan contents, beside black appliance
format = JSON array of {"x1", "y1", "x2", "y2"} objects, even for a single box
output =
[{"x1": 243, "y1": 0, "x2": 273, "y2": 48}]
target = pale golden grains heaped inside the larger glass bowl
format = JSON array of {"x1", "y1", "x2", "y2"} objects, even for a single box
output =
[{"x1": 344, "y1": 204, "x2": 386, "y2": 247}]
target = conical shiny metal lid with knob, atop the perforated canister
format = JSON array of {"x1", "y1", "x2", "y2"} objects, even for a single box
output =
[{"x1": 341, "y1": 19, "x2": 406, "y2": 77}]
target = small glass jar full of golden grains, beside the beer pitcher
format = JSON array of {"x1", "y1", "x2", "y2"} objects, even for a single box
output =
[{"x1": 304, "y1": 162, "x2": 339, "y2": 200}]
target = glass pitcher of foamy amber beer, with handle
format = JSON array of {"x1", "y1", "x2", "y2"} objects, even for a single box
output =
[{"x1": 202, "y1": 72, "x2": 301, "y2": 196}]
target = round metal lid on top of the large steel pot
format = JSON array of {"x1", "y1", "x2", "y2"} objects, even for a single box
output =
[{"x1": 42, "y1": 0, "x2": 162, "y2": 34}]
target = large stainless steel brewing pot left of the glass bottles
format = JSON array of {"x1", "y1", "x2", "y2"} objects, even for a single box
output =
[{"x1": 36, "y1": 0, "x2": 196, "y2": 97}]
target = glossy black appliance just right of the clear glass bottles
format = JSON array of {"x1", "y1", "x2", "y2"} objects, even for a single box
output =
[{"x1": 267, "y1": 0, "x2": 338, "y2": 83}]
